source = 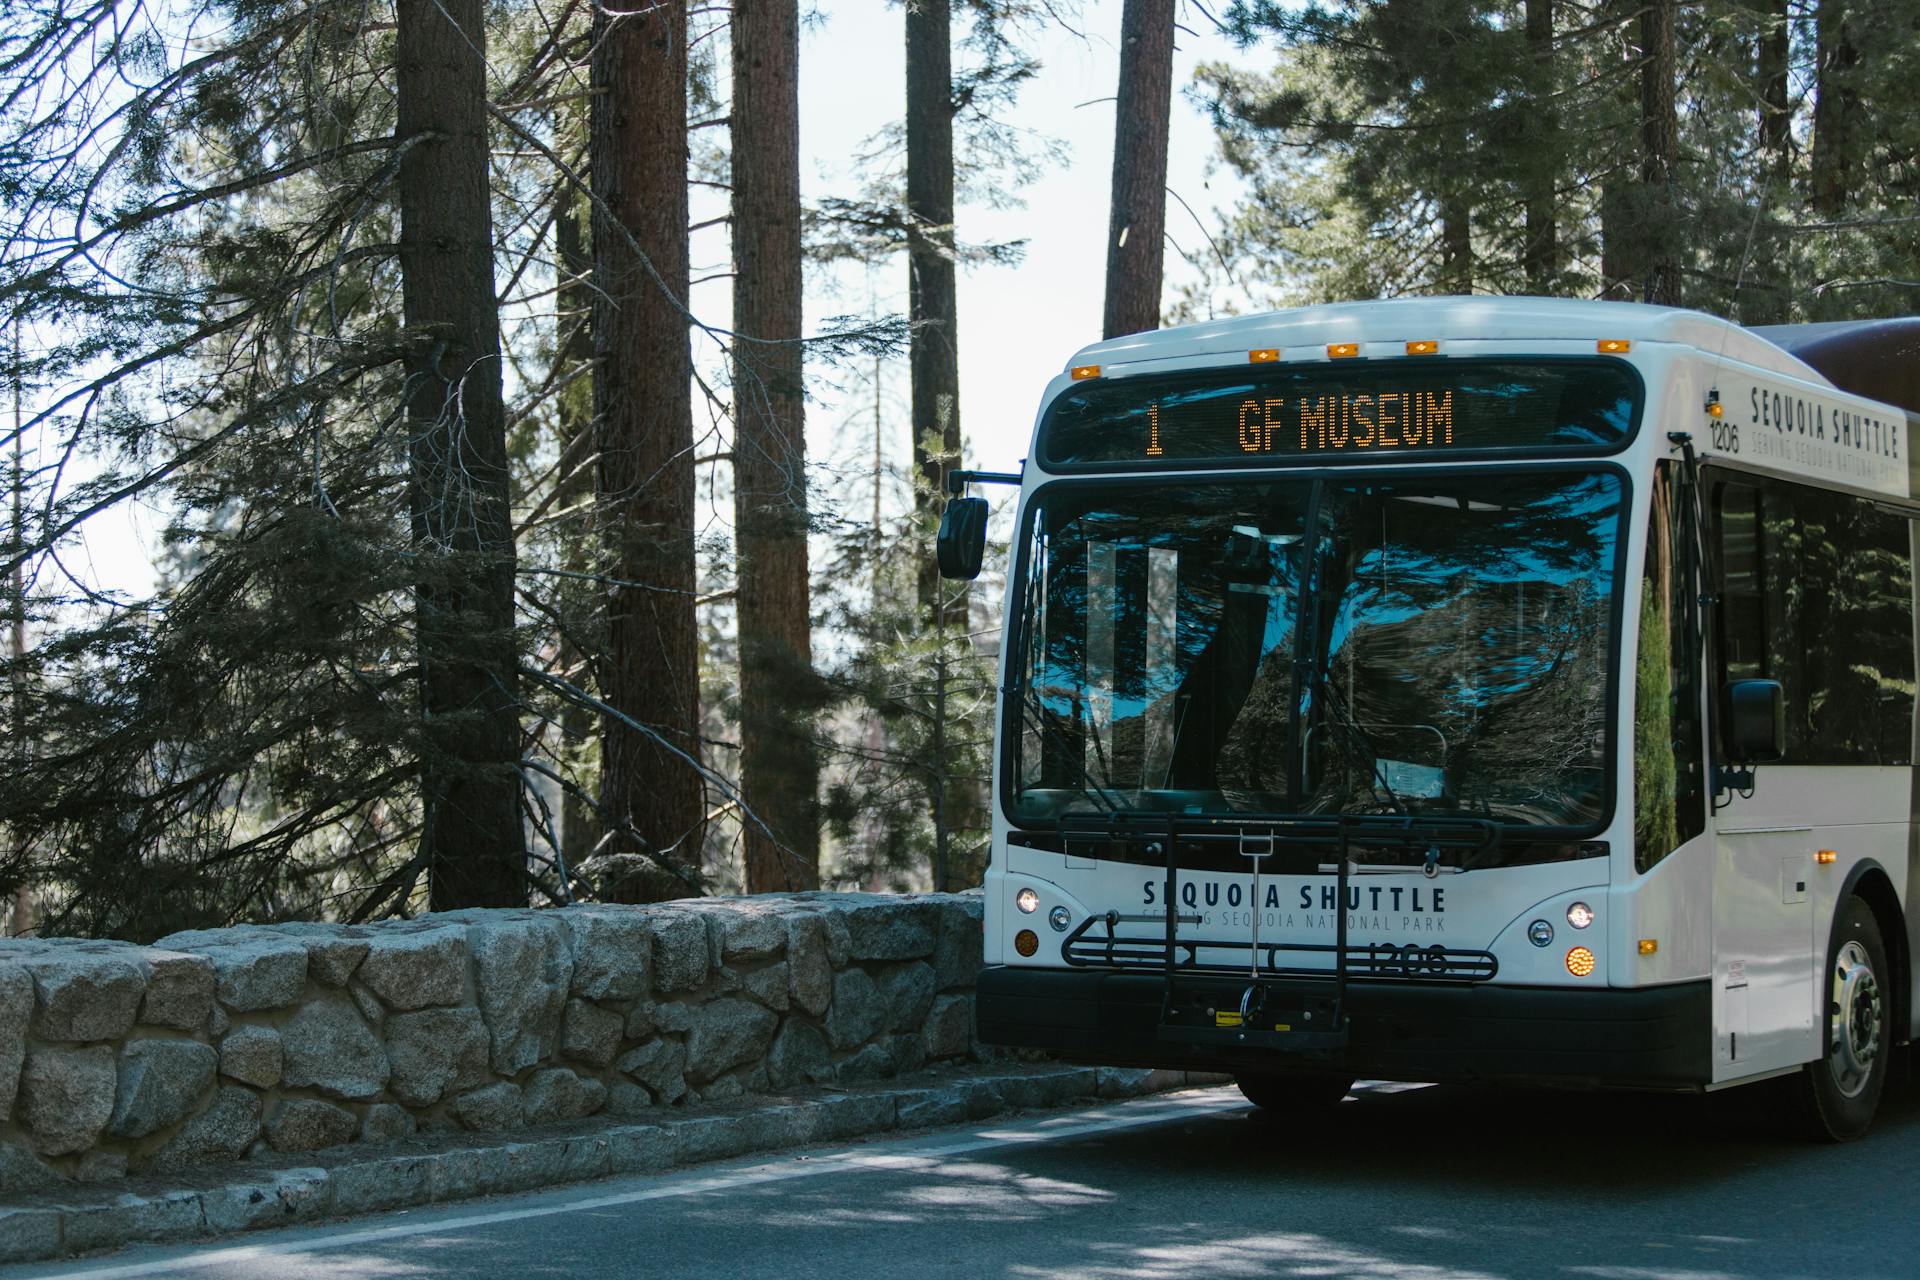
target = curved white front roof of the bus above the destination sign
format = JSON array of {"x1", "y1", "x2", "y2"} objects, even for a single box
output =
[{"x1": 1069, "y1": 297, "x2": 1826, "y2": 382}]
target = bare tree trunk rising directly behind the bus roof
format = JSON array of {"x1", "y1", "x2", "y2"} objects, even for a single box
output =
[{"x1": 1102, "y1": 0, "x2": 1173, "y2": 338}]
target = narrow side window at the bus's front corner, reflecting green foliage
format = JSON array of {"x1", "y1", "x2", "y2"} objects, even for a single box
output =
[{"x1": 1634, "y1": 462, "x2": 1707, "y2": 871}]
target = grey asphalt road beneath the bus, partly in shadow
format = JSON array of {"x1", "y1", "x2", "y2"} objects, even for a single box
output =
[{"x1": 15, "y1": 1084, "x2": 1920, "y2": 1280}]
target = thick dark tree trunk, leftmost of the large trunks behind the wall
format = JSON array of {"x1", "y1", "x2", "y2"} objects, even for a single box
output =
[{"x1": 396, "y1": 0, "x2": 528, "y2": 910}]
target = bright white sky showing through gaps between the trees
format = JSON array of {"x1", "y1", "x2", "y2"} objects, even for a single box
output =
[{"x1": 56, "y1": 0, "x2": 1263, "y2": 595}]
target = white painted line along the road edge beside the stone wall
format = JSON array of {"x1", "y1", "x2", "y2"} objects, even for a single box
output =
[{"x1": 41, "y1": 1092, "x2": 1248, "y2": 1280}]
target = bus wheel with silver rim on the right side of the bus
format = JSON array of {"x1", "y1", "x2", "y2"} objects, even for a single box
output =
[{"x1": 1793, "y1": 898, "x2": 1893, "y2": 1142}]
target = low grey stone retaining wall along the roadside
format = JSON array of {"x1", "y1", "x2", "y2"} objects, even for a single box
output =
[{"x1": 0, "y1": 894, "x2": 981, "y2": 1192}]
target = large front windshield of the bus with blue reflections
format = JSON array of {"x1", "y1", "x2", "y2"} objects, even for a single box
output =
[{"x1": 1004, "y1": 470, "x2": 1624, "y2": 829}]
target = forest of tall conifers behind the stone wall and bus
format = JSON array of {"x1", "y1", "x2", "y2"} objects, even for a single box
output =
[{"x1": 0, "y1": 0, "x2": 1920, "y2": 938}]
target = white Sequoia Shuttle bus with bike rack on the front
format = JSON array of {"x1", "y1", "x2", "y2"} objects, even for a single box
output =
[{"x1": 941, "y1": 297, "x2": 1920, "y2": 1140}]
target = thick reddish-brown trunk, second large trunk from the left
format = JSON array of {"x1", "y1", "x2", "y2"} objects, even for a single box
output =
[{"x1": 591, "y1": 0, "x2": 705, "y2": 886}]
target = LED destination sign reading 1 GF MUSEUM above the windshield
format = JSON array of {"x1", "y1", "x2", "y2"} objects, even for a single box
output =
[{"x1": 1041, "y1": 361, "x2": 1640, "y2": 468}]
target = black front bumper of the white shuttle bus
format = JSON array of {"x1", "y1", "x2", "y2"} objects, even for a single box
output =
[{"x1": 975, "y1": 965, "x2": 1713, "y2": 1088}]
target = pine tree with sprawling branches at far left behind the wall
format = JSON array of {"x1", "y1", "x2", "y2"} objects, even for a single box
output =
[{"x1": 0, "y1": 4, "x2": 618, "y2": 936}]
